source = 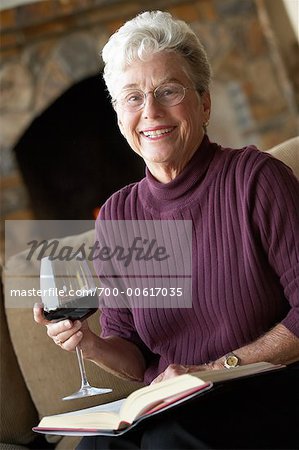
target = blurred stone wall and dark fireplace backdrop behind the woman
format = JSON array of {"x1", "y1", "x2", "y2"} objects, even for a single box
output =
[{"x1": 0, "y1": 0, "x2": 299, "y2": 230}]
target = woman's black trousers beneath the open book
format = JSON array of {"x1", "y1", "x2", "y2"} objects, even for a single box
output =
[{"x1": 77, "y1": 365, "x2": 299, "y2": 450}]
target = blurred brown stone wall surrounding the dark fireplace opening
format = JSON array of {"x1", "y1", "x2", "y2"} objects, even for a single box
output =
[{"x1": 0, "y1": 0, "x2": 298, "y2": 229}]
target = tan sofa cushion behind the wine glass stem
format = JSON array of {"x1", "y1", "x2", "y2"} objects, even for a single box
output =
[{"x1": 4, "y1": 231, "x2": 140, "y2": 424}]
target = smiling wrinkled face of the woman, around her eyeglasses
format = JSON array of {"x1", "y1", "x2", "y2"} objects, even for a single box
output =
[{"x1": 116, "y1": 52, "x2": 210, "y2": 176}]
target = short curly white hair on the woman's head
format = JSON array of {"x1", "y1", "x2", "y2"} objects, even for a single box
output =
[{"x1": 102, "y1": 11, "x2": 211, "y2": 99}]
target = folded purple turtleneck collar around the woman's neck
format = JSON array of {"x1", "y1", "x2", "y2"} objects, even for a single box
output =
[{"x1": 145, "y1": 135, "x2": 215, "y2": 209}]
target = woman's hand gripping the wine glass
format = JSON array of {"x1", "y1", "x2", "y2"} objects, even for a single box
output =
[{"x1": 33, "y1": 303, "x2": 92, "y2": 354}]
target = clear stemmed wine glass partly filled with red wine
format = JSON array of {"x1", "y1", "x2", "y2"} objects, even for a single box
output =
[{"x1": 40, "y1": 255, "x2": 112, "y2": 400}]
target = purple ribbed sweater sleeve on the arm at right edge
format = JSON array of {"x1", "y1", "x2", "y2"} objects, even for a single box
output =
[{"x1": 252, "y1": 155, "x2": 299, "y2": 337}]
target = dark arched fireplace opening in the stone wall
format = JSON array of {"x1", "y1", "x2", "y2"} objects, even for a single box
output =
[{"x1": 14, "y1": 75, "x2": 144, "y2": 220}]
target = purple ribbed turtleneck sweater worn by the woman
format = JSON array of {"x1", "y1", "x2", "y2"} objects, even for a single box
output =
[{"x1": 99, "y1": 136, "x2": 299, "y2": 383}]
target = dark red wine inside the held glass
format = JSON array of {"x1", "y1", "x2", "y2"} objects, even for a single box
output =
[{"x1": 44, "y1": 295, "x2": 98, "y2": 320}]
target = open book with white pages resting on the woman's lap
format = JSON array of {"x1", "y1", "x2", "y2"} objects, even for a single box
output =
[{"x1": 33, "y1": 363, "x2": 282, "y2": 435}]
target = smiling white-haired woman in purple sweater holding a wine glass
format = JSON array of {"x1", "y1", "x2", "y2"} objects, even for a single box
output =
[{"x1": 35, "y1": 11, "x2": 299, "y2": 449}]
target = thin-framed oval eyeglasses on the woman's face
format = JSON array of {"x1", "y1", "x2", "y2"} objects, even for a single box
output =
[{"x1": 114, "y1": 83, "x2": 196, "y2": 112}]
